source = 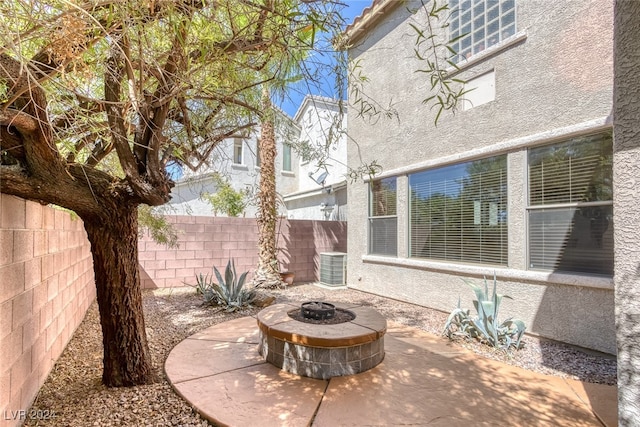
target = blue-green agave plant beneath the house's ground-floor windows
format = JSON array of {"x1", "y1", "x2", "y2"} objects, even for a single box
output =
[{"x1": 442, "y1": 275, "x2": 526, "y2": 350}]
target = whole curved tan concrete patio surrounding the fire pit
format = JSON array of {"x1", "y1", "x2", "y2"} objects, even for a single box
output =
[{"x1": 165, "y1": 317, "x2": 617, "y2": 427}]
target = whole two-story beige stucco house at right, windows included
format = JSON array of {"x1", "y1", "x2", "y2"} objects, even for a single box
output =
[{"x1": 346, "y1": 0, "x2": 616, "y2": 356}]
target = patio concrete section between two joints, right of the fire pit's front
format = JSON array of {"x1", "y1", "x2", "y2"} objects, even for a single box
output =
[{"x1": 314, "y1": 335, "x2": 602, "y2": 426}]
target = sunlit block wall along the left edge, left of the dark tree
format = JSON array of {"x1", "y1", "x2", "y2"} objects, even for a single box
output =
[{"x1": 0, "y1": 194, "x2": 95, "y2": 426}]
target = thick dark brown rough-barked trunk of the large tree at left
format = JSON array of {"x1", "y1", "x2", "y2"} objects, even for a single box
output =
[{"x1": 83, "y1": 203, "x2": 156, "y2": 387}]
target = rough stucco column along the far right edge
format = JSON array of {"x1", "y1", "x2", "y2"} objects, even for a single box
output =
[{"x1": 613, "y1": 0, "x2": 640, "y2": 426}]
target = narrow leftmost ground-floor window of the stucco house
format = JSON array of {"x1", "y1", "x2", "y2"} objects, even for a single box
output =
[{"x1": 369, "y1": 177, "x2": 398, "y2": 256}]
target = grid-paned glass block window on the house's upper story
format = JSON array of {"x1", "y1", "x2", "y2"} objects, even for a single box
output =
[{"x1": 449, "y1": 0, "x2": 516, "y2": 62}]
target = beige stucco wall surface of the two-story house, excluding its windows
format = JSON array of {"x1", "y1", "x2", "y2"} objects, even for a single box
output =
[{"x1": 347, "y1": 0, "x2": 616, "y2": 353}]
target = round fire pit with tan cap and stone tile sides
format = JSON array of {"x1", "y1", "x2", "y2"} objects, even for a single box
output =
[{"x1": 258, "y1": 304, "x2": 387, "y2": 379}]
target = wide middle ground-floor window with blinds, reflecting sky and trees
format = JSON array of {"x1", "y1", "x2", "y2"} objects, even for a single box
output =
[{"x1": 409, "y1": 155, "x2": 508, "y2": 265}]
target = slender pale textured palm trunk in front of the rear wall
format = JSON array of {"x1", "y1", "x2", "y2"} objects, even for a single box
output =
[{"x1": 254, "y1": 89, "x2": 282, "y2": 288}]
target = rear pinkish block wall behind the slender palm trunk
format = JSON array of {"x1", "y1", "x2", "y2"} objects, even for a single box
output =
[{"x1": 138, "y1": 215, "x2": 347, "y2": 288}]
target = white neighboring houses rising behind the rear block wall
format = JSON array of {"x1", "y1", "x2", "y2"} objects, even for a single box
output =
[{"x1": 164, "y1": 96, "x2": 346, "y2": 220}]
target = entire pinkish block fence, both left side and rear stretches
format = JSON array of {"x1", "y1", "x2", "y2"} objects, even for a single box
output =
[{"x1": 0, "y1": 194, "x2": 347, "y2": 427}]
